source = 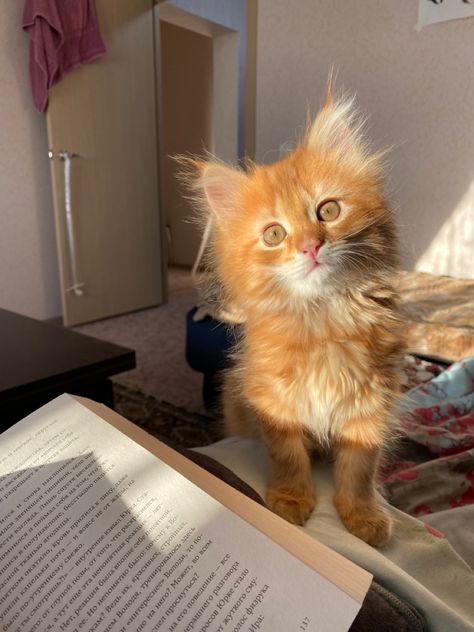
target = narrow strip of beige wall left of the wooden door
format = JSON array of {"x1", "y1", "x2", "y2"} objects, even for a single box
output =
[{"x1": 0, "y1": 2, "x2": 61, "y2": 318}]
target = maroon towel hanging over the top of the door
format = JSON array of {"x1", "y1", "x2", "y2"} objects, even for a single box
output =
[{"x1": 22, "y1": 0, "x2": 106, "y2": 112}]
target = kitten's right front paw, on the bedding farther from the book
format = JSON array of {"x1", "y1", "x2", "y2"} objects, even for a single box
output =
[{"x1": 334, "y1": 497, "x2": 392, "y2": 547}]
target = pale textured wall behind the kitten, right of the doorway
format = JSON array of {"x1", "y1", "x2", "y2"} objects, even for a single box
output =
[{"x1": 256, "y1": 0, "x2": 474, "y2": 277}]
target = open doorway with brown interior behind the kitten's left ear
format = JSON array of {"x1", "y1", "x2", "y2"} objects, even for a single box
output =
[{"x1": 156, "y1": 2, "x2": 242, "y2": 268}]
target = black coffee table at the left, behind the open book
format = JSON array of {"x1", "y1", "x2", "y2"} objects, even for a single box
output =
[{"x1": 0, "y1": 309, "x2": 136, "y2": 432}]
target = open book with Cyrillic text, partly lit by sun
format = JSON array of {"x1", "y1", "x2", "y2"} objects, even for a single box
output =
[{"x1": 0, "y1": 395, "x2": 371, "y2": 632}]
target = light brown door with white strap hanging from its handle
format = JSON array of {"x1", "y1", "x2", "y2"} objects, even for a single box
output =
[{"x1": 47, "y1": 0, "x2": 164, "y2": 325}]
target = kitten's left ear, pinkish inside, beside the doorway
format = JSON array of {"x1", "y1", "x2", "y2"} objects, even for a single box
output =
[{"x1": 200, "y1": 162, "x2": 247, "y2": 218}]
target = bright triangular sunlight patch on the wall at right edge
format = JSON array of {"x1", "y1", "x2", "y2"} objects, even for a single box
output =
[{"x1": 415, "y1": 180, "x2": 474, "y2": 279}]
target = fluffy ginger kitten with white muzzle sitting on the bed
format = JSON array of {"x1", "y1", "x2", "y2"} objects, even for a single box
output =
[{"x1": 185, "y1": 90, "x2": 403, "y2": 546}]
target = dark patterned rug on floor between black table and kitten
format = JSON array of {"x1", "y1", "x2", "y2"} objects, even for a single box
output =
[{"x1": 114, "y1": 383, "x2": 224, "y2": 448}]
